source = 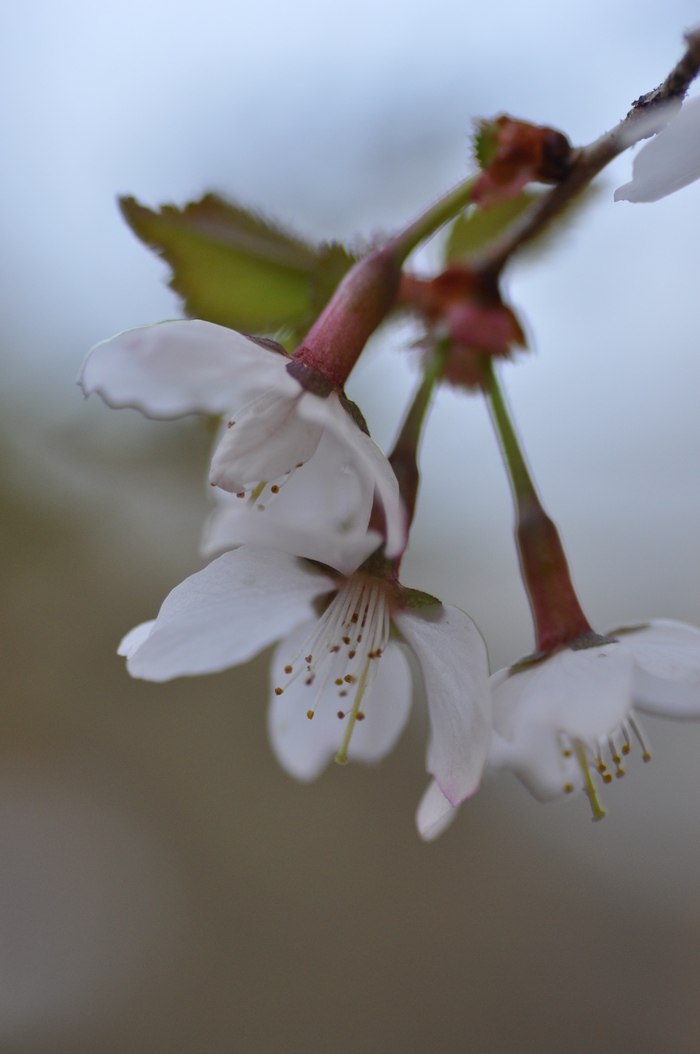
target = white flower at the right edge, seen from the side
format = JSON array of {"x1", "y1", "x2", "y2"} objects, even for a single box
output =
[{"x1": 419, "y1": 620, "x2": 700, "y2": 838}]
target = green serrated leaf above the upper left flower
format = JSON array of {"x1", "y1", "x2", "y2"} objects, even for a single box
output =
[{"x1": 119, "y1": 194, "x2": 354, "y2": 335}]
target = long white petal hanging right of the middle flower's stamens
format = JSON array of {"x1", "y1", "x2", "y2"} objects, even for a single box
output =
[{"x1": 394, "y1": 604, "x2": 491, "y2": 805}]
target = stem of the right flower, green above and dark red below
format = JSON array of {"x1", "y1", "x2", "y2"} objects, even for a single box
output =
[{"x1": 482, "y1": 356, "x2": 592, "y2": 652}]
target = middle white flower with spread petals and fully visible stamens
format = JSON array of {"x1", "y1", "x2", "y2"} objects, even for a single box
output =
[{"x1": 119, "y1": 546, "x2": 490, "y2": 805}]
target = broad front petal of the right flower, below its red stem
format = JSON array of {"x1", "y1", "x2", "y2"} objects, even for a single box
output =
[{"x1": 491, "y1": 644, "x2": 634, "y2": 742}]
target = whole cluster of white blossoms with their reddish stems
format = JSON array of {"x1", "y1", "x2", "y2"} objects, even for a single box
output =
[{"x1": 79, "y1": 63, "x2": 700, "y2": 839}]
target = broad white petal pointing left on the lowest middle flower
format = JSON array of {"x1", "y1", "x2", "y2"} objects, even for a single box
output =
[{"x1": 122, "y1": 546, "x2": 334, "y2": 681}]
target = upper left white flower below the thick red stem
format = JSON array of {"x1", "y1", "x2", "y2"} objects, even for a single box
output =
[{"x1": 79, "y1": 320, "x2": 406, "y2": 568}]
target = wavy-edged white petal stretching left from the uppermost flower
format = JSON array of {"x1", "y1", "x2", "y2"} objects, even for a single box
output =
[{"x1": 78, "y1": 320, "x2": 286, "y2": 417}]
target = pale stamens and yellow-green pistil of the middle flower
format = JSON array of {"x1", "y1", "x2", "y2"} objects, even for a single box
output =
[{"x1": 274, "y1": 574, "x2": 391, "y2": 764}]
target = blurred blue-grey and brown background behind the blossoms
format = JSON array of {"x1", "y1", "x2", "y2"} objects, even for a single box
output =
[{"x1": 0, "y1": 0, "x2": 700, "y2": 1054}]
